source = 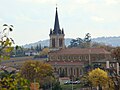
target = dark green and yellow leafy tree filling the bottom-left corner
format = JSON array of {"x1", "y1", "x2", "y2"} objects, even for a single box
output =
[{"x1": 0, "y1": 69, "x2": 30, "y2": 90}]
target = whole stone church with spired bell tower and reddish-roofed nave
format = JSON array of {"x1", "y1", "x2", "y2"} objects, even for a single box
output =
[{"x1": 48, "y1": 7, "x2": 111, "y2": 77}]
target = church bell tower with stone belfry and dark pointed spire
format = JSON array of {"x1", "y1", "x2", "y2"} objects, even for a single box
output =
[{"x1": 49, "y1": 7, "x2": 65, "y2": 50}]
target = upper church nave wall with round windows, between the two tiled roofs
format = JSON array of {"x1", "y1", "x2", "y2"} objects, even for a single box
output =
[{"x1": 49, "y1": 54, "x2": 110, "y2": 62}]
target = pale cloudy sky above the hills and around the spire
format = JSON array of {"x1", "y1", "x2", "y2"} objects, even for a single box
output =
[{"x1": 0, "y1": 0, "x2": 120, "y2": 45}]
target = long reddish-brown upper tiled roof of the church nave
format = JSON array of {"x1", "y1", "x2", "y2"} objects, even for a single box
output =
[{"x1": 49, "y1": 48, "x2": 110, "y2": 54}]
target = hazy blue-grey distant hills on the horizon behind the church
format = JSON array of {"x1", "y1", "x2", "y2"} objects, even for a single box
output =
[{"x1": 23, "y1": 36, "x2": 120, "y2": 48}]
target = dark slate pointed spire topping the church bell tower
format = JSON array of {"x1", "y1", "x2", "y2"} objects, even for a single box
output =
[{"x1": 54, "y1": 7, "x2": 60, "y2": 34}]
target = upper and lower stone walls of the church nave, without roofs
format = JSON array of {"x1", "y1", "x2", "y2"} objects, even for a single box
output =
[{"x1": 48, "y1": 50, "x2": 110, "y2": 77}]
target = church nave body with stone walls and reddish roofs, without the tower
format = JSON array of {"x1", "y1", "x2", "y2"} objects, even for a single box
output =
[{"x1": 48, "y1": 48, "x2": 111, "y2": 77}]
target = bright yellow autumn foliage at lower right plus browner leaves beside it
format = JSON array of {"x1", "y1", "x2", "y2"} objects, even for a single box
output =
[{"x1": 88, "y1": 68, "x2": 114, "y2": 90}]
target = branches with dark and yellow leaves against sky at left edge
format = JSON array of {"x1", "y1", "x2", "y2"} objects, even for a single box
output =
[{"x1": 0, "y1": 24, "x2": 14, "y2": 60}]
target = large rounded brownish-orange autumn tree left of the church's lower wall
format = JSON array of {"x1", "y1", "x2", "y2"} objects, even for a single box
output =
[{"x1": 21, "y1": 61, "x2": 53, "y2": 87}]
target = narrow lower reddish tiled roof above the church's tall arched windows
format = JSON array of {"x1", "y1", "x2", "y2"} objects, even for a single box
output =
[{"x1": 48, "y1": 61, "x2": 84, "y2": 66}]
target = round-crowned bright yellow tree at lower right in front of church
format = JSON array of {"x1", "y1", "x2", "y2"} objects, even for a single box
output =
[{"x1": 89, "y1": 68, "x2": 113, "y2": 90}]
